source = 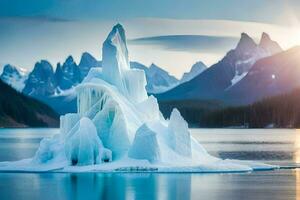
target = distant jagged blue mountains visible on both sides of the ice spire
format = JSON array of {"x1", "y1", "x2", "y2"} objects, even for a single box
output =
[{"x1": 0, "y1": 49, "x2": 206, "y2": 114}]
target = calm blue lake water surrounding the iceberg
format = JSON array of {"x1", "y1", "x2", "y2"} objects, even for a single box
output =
[{"x1": 0, "y1": 129, "x2": 300, "y2": 200}]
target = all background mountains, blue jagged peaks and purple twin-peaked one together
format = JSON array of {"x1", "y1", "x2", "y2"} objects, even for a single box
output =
[{"x1": 1, "y1": 26, "x2": 300, "y2": 118}]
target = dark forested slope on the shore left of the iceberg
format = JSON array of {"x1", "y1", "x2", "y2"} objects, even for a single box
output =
[{"x1": 0, "y1": 81, "x2": 59, "y2": 127}]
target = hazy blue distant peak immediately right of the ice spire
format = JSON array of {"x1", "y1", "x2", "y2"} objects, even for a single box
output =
[{"x1": 130, "y1": 62, "x2": 179, "y2": 94}]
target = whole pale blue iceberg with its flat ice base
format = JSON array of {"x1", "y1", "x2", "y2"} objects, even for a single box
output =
[{"x1": 0, "y1": 24, "x2": 276, "y2": 172}]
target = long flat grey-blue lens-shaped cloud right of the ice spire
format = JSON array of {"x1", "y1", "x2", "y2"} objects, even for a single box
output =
[{"x1": 129, "y1": 35, "x2": 239, "y2": 53}]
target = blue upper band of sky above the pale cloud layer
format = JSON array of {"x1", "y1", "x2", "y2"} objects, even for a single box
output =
[{"x1": 0, "y1": 0, "x2": 300, "y2": 24}]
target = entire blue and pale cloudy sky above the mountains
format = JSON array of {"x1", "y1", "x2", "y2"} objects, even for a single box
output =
[{"x1": 0, "y1": 0, "x2": 300, "y2": 78}]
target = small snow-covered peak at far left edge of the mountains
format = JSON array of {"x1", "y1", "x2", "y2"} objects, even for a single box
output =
[{"x1": 0, "y1": 64, "x2": 27, "y2": 92}]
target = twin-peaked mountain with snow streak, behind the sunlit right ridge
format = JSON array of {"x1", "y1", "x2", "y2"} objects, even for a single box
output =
[{"x1": 157, "y1": 33, "x2": 281, "y2": 100}]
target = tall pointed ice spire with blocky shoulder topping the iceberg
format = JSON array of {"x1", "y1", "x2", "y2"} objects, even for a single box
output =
[{"x1": 102, "y1": 24, "x2": 147, "y2": 102}]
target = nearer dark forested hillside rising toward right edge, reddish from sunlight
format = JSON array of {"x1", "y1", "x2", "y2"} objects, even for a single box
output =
[{"x1": 199, "y1": 89, "x2": 300, "y2": 128}]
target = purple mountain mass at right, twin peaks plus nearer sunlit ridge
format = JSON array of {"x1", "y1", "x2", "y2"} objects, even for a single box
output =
[{"x1": 156, "y1": 33, "x2": 290, "y2": 105}]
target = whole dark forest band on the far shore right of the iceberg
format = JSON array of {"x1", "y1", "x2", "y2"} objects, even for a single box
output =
[{"x1": 161, "y1": 89, "x2": 300, "y2": 128}]
